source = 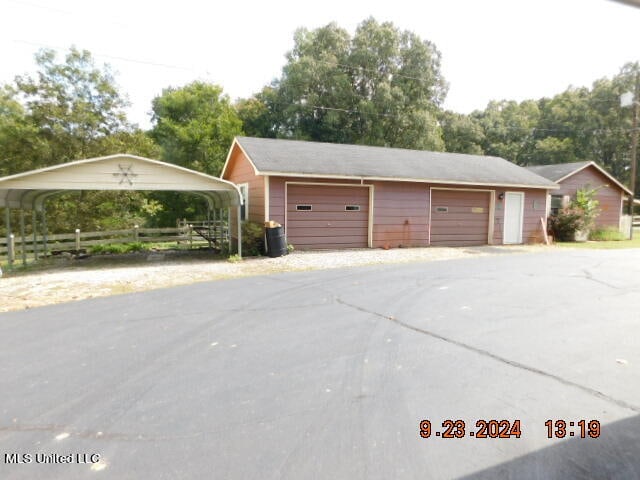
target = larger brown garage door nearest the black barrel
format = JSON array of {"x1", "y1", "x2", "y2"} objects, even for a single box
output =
[{"x1": 286, "y1": 184, "x2": 369, "y2": 250}]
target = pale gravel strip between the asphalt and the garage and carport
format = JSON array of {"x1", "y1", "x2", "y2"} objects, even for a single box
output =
[{"x1": 0, "y1": 245, "x2": 552, "y2": 312}]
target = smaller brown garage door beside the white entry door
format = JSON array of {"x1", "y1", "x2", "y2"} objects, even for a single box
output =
[{"x1": 431, "y1": 189, "x2": 490, "y2": 247}]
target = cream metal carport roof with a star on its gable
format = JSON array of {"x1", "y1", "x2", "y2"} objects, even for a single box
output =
[{"x1": 0, "y1": 154, "x2": 242, "y2": 210}]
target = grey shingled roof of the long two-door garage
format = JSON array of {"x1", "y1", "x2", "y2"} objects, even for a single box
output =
[{"x1": 229, "y1": 137, "x2": 558, "y2": 189}]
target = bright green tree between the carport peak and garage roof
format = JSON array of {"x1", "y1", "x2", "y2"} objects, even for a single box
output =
[{"x1": 150, "y1": 82, "x2": 242, "y2": 175}]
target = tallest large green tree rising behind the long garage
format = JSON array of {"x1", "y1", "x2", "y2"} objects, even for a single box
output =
[{"x1": 240, "y1": 18, "x2": 447, "y2": 150}]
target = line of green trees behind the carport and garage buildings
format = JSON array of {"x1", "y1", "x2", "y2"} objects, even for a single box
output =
[{"x1": 0, "y1": 18, "x2": 639, "y2": 230}]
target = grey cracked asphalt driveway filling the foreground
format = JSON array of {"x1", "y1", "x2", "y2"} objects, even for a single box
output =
[{"x1": 0, "y1": 250, "x2": 640, "y2": 480}]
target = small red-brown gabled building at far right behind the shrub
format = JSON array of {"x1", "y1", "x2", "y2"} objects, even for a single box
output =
[{"x1": 527, "y1": 161, "x2": 632, "y2": 229}]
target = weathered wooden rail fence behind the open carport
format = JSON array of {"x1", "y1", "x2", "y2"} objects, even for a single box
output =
[{"x1": 0, "y1": 224, "x2": 209, "y2": 261}]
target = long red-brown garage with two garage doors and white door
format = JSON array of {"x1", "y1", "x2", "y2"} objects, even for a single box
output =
[{"x1": 221, "y1": 137, "x2": 558, "y2": 249}]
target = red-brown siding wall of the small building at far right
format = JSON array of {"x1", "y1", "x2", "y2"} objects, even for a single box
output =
[{"x1": 551, "y1": 165, "x2": 624, "y2": 228}]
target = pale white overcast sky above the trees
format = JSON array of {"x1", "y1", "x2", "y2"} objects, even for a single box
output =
[{"x1": 0, "y1": 0, "x2": 640, "y2": 128}]
